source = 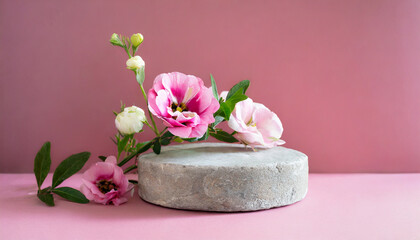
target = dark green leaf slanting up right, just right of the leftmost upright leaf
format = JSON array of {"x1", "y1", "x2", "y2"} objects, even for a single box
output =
[{"x1": 52, "y1": 152, "x2": 90, "y2": 188}]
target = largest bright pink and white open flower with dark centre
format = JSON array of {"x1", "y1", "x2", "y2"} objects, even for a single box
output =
[{"x1": 149, "y1": 72, "x2": 219, "y2": 138}]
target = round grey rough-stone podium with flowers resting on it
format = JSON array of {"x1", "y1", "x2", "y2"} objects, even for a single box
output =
[{"x1": 138, "y1": 143, "x2": 308, "y2": 212}]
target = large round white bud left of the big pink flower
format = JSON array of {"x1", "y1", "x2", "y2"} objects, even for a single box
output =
[{"x1": 115, "y1": 106, "x2": 147, "y2": 135}]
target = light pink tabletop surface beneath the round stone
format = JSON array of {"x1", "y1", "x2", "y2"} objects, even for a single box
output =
[{"x1": 0, "y1": 174, "x2": 420, "y2": 240}]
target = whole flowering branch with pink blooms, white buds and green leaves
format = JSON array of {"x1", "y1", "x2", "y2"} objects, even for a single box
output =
[{"x1": 34, "y1": 33, "x2": 284, "y2": 206}]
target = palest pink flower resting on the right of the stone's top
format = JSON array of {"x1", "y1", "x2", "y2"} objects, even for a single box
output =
[{"x1": 228, "y1": 98, "x2": 285, "y2": 148}]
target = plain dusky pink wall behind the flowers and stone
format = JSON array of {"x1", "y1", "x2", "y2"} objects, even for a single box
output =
[{"x1": 0, "y1": 0, "x2": 420, "y2": 172}]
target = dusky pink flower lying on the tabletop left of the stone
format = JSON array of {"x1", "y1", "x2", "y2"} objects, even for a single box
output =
[{"x1": 81, "y1": 156, "x2": 129, "y2": 206}]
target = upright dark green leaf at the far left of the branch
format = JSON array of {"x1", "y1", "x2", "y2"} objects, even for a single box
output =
[{"x1": 34, "y1": 142, "x2": 51, "y2": 189}]
